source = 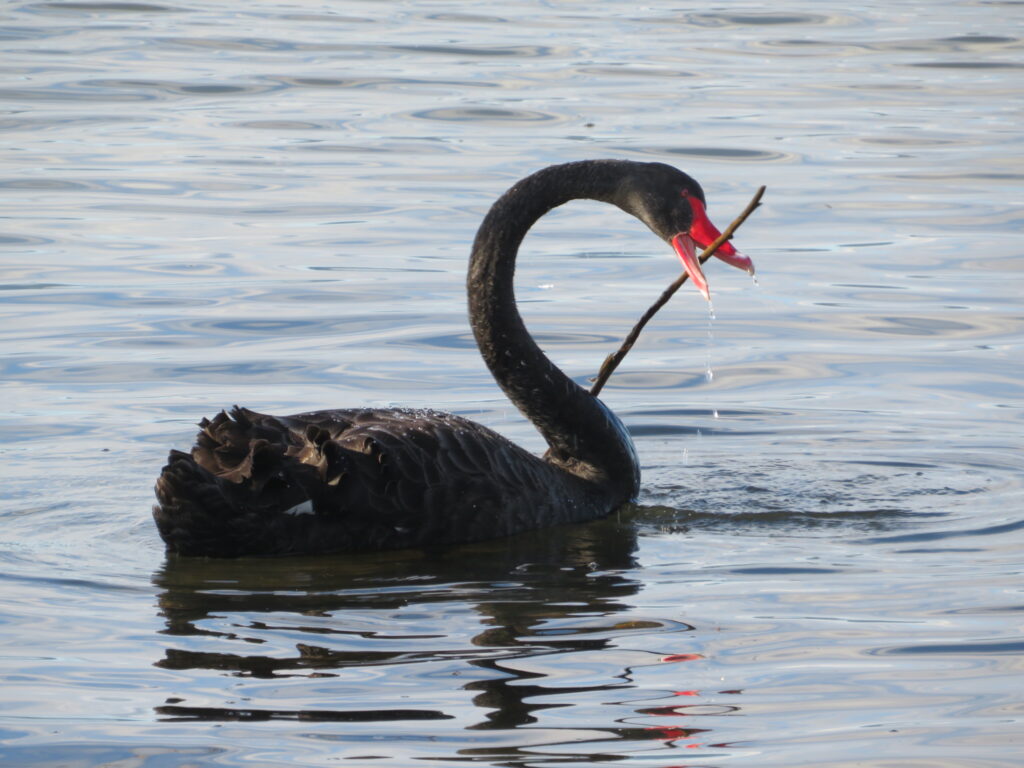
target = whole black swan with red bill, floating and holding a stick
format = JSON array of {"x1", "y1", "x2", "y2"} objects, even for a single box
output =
[{"x1": 154, "y1": 160, "x2": 752, "y2": 557}]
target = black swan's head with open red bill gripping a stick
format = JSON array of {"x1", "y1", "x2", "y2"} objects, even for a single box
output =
[{"x1": 623, "y1": 163, "x2": 754, "y2": 301}]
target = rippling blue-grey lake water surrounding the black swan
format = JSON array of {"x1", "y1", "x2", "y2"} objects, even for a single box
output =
[{"x1": 0, "y1": 0, "x2": 1024, "y2": 768}]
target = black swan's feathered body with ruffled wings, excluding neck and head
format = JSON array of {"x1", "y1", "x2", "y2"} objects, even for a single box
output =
[{"x1": 154, "y1": 408, "x2": 607, "y2": 557}]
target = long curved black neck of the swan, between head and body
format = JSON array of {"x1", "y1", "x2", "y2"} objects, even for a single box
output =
[{"x1": 467, "y1": 161, "x2": 640, "y2": 501}]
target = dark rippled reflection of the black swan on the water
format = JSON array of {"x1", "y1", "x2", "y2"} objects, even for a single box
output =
[{"x1": 154, "y1": 517, "x2": 720, "y2": 753}]
